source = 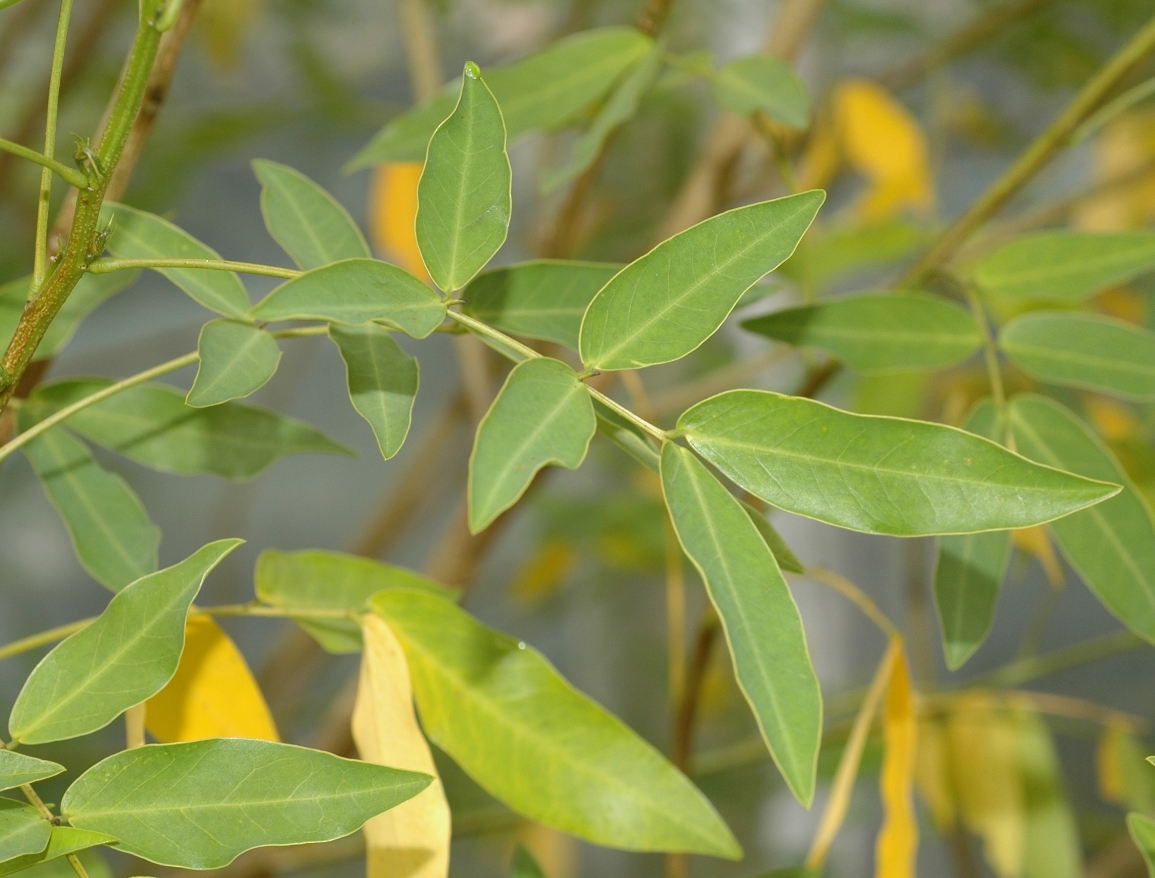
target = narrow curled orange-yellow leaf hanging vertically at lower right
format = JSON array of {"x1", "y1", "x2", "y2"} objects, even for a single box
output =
[{"x1": 874, "y1": 649, "x2": 918, "y2": 878}]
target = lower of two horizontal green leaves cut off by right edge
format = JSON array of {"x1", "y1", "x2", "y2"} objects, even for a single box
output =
[{"x1": 999, "y1": 311, "x2": 1155, "y2": 400}]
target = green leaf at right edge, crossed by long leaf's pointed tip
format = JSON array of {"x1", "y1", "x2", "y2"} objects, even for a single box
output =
[{"x1": 1011, "y1": 394, "x2": 1155, "y2": 642}]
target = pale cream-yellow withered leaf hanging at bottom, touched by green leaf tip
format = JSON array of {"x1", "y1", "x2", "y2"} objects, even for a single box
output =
[{"x1": 353, "y1": 616, "x2": 450, "y2": 878}]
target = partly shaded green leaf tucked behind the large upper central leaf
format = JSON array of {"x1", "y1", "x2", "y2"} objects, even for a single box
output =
[{"x1": 461, "y1": 259, "x2": 621, "y2": 350}]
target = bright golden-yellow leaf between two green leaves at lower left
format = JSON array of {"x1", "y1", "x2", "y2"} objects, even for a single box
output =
[{"x1": 146, "y1": 616, "x2": 281, "y2": 744}]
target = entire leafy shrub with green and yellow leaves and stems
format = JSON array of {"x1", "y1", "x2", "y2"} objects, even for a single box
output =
[{"x1": 0, "y1": 0, "x2": 1155, "y2": 878}]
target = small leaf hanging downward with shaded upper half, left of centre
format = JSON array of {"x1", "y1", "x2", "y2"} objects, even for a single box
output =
[{"x1": 329, "y1": 323, "x2": 420, "y2": 460}]
